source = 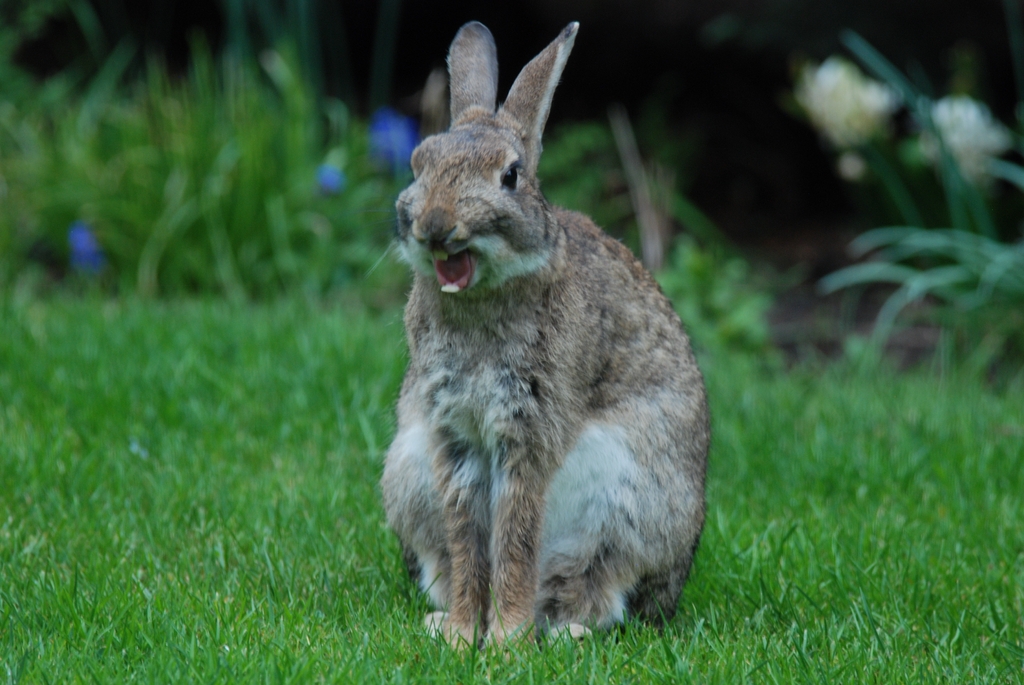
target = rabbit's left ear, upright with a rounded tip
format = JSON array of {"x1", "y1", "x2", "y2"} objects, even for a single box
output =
[{"x1": 449, "y1": 22, "x2": 498, "y2": 125}]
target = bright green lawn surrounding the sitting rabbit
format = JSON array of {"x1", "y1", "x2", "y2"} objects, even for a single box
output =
[{"x1": 0, "y1": 300, "x2": 1024, "y2": 683}]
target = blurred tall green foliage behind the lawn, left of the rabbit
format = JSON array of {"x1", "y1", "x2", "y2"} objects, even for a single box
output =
[{"x1": 0, "y1": 46, "x2": 402, "y2": 298}]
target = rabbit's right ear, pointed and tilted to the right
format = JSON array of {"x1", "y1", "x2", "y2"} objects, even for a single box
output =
[{"x1": 502, "y1": 22, "x2": 580, "y2": 172}]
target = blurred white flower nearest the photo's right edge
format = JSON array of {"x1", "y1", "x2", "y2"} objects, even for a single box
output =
[{"x1": 921, "y1": 95, "x2": 1012, "y2": 183}]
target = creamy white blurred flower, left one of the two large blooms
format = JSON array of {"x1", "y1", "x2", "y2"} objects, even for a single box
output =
[{"x1": 795, "y1": 56, "x2": 899, "y2": 148}]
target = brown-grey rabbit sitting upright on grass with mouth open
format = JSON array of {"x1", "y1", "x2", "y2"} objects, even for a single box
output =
[{"x1": 381, "y1": 18, "x2": 711, "y2": 646}]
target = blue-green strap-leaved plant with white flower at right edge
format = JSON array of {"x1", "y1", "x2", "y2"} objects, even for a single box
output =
[{"x1": 820, "y1": 21, "x2": 1024, "y2": 352}]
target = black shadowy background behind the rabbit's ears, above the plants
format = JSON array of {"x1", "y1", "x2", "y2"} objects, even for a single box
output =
[{"x1": 8, "y1": 0, "x2": 1016, "y2": 264}]
